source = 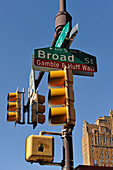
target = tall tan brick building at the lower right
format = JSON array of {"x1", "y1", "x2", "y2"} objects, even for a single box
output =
[{"x1": 82, "y1": 110, "x2": 113, "y2": 167}]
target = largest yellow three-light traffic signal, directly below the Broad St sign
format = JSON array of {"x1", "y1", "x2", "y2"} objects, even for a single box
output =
[{"x1": 48, "y1": 68, "x2": 75, "y2": 126}]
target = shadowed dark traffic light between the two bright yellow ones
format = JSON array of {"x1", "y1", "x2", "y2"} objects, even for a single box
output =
[{"x1": 31, "y1": 94, "x2": 45, "y2": 125}]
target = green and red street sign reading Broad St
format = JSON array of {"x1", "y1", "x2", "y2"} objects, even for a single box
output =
[{"x1": 32, "y1": 47, "x2": 97, "y2": 75}]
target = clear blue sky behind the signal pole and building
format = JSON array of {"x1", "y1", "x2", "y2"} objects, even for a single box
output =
[{"x1": 0, "y1": 0, "x2": 113, "y2": 170}]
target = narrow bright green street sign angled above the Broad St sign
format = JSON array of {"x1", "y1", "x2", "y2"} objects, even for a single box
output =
[{"x1": 55, "y1": 22, "x2": 69, "y2": 47}]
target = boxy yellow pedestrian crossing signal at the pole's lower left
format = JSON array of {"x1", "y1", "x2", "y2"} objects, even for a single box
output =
[{"x1": 25, "y1": 135, "x2": 54, "y2": 163}]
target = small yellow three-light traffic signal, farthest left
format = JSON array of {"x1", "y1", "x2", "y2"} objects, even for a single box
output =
[{"x1": 7, "y1": 89, "x2": 21, "y2": 122}]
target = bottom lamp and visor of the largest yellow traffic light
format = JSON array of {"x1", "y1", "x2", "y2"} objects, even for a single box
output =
[{"x1": 49, "y1": 107, "x2": 68, "y2": 125}]
